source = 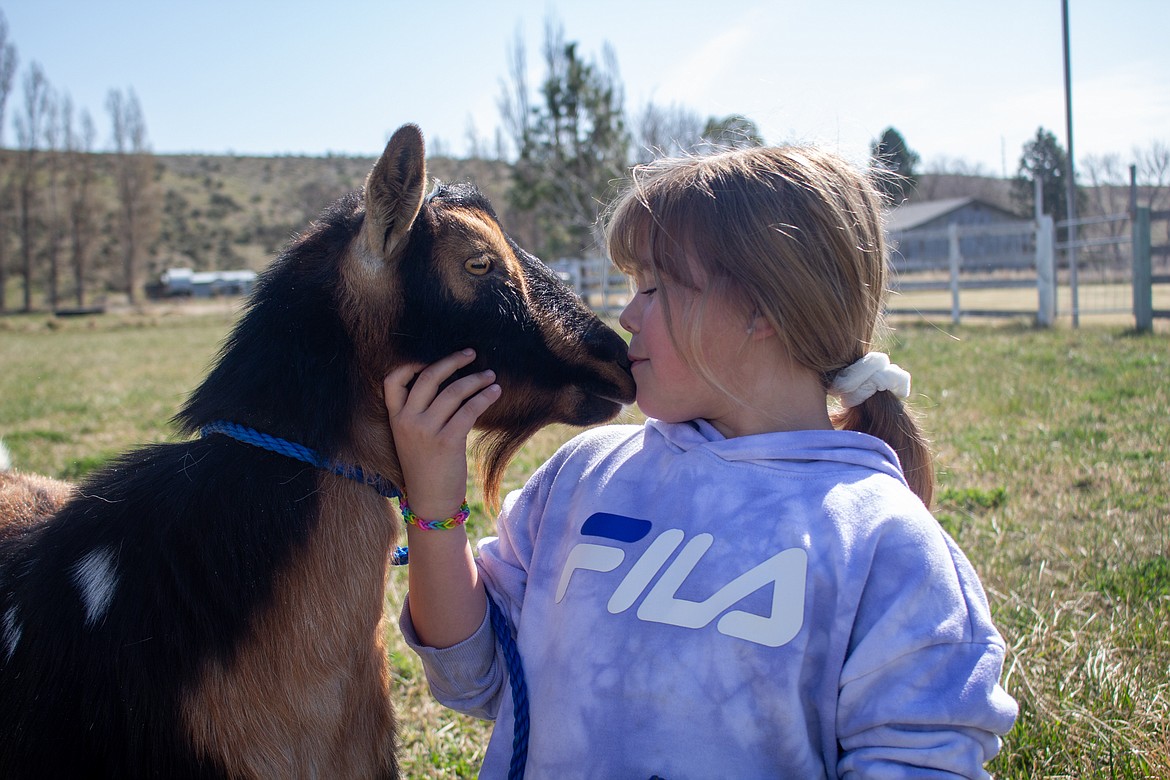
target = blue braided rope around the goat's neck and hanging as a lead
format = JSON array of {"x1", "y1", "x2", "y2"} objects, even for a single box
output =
[{"x1": 199, "y1": 420, "x2": 529, "y2": 780}]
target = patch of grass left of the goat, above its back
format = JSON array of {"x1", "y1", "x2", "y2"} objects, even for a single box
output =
[{"x1": 0, "y1": 309, "x2": 234, "y2": 478}]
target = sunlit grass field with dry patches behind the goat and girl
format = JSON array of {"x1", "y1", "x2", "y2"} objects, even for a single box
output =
[{"x1": 0, "y1": 310, "x2": 1170, "y2": 779}]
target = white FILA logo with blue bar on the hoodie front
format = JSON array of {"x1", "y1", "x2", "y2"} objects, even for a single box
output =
[{"x1": 556, "y1": 512, "x2": 808, "y2": 648}]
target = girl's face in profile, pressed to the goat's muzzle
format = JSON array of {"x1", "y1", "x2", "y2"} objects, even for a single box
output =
[{"x1": 619, "y1": 269, "x2": 748, "y2": 428}]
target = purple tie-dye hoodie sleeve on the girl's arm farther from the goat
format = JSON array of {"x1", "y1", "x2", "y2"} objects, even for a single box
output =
[{"x1": 837, "y1": 518, "x2": 1017, "y2": 778}]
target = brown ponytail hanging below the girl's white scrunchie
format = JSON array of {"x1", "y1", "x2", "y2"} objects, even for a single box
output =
[{"x1": 833, "y1": 392, "x2": 935, "y2": 506}]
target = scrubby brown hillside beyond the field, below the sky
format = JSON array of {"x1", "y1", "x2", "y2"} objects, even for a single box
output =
[{"x1": 0, "y1": 150, "x2": 1029, "y2": 311}]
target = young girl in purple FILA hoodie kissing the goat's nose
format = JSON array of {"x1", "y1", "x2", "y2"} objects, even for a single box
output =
[{"x1": 386, "y1": 147, "x2": 1016, "y2": 780}]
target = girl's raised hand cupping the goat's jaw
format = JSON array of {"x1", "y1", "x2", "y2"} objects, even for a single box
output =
[{"x1": 383, "y1": 350, "x2": 500, "y2": 520}]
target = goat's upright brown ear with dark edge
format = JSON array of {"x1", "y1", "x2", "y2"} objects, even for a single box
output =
[{"x1": 364, "y1": 125, "x2": 427, "y2": 258}]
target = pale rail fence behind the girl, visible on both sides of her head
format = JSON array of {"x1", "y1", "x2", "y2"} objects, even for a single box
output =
[{"x1": 550, "y1": 208, "x2": 1170, "y2": 330}]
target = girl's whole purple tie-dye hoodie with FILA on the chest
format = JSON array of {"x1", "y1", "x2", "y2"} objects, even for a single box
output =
[{"x1": 401, "y1": 420, "x2": 1017, "y2": 780}]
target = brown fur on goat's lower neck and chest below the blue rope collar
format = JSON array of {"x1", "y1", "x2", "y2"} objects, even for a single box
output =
[{"x1": 186, "y1": 437, "x2": 398, "y2": 776}]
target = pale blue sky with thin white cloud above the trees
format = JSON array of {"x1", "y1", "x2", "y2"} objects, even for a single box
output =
[{"x1": 0, "y1": 0, "x2": 1170, "y2": 175}]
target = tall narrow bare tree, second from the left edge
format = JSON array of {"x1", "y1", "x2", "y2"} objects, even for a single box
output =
[{"x1": 16, "y1": 62, "x2": 49, "y2": 311}]
